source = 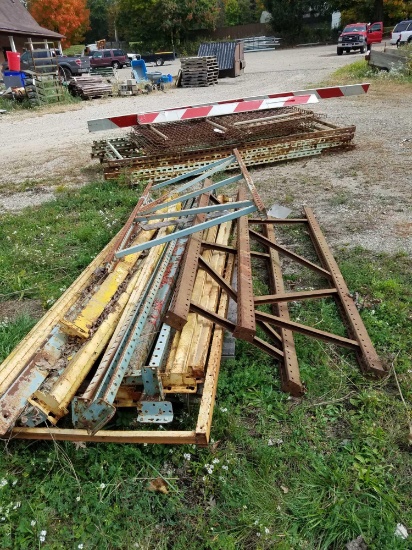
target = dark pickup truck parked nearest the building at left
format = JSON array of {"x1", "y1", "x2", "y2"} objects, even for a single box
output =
[{"x1": 2, "y1": 49, "x2": 90, "y2": 80}]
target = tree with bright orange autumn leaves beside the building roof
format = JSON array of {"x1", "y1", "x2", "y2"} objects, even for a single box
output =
[{"x1": 28, "y1": 0, "x2": 90, "y2": 47}]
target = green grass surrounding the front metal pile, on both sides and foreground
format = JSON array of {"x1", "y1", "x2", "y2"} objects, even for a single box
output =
[{"x1": 0, "y1": 182, "x2": 412, "y2": 550}]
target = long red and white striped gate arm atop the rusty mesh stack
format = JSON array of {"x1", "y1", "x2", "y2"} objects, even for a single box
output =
[{"x1": 87, "y1": 84, "x2": 370, "y2": 132}]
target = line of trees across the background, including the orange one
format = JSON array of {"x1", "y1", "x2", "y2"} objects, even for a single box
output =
[{"x1": 27, "y1": 0, "x2": 412, "y2": 49}]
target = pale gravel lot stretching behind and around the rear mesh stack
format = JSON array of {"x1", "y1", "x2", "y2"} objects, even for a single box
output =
[{"x1": 0, "y1": 46, "x2": 412, "y2": 254}]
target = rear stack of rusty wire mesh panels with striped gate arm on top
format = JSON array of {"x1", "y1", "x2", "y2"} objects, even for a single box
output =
[{"x1": 89, "y1": 84, "x2": 369, "y2": 182}]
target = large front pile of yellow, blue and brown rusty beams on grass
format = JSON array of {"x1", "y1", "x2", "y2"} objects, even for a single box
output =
[{"x1": 0, "y1": 149, "x2": 384, "y2": 445}]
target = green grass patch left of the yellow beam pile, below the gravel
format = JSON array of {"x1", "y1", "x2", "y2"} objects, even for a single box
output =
[{"x1": 0, "y1": 182, "x2": 138, "y2": 310}]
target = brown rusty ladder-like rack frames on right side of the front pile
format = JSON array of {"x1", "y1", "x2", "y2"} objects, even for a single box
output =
[{"x1": 165, "y1": 208, "x2": 385, "y2": 402}]
